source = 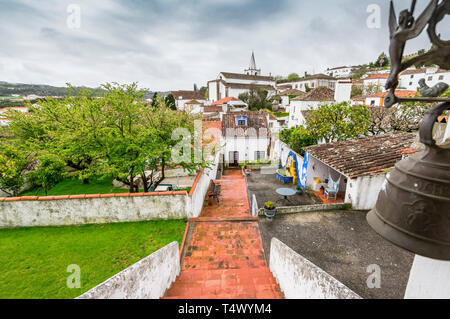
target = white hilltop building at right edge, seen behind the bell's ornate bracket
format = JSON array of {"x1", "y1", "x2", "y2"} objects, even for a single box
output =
[{"x1": 399, "y1": 67, "x2": 450, "y2": 91}]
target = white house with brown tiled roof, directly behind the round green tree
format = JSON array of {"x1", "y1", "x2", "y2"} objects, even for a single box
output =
[{"x1": 288, "y1": 87, "x2": 335, "y2": 128}]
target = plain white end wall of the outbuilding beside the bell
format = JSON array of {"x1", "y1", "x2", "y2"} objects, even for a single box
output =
[{"x1": 345, "y1": 174, "x2": 386, "y2": 210}]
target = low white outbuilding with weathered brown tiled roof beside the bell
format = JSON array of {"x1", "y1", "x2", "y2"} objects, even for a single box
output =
[{"x1": 304, "y1": 133, "x2": 416, "y2": 210}]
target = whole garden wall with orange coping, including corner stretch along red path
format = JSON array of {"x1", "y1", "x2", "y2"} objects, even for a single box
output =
[{"x1": 0, "y1": 155, "x2": 219, "y2": 228}]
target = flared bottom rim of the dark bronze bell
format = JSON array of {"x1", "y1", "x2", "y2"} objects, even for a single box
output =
[{"x1": 366, "y1": 208, "x2": 450, "y2": 260}]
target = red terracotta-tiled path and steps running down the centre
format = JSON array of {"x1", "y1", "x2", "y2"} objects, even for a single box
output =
[{"x1": 165, "y1": 170, "x2": 283, "y2": 299}]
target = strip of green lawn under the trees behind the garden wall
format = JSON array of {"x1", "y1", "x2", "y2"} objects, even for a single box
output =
[{"x1": 21, "y1": 178, "x2": 128, "y2": 196}]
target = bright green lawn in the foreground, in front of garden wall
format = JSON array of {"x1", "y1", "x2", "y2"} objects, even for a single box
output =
[{"x1": 0, "y1": 220, "x2": 185, "y2": 299}]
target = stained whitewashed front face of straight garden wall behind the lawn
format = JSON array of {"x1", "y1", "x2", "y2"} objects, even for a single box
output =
[{"x1": 0, "y1": 192, "x2": 189, "y2": 228}]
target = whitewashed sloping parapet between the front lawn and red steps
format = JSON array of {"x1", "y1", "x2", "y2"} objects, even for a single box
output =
[{"x1": 77, "y1": 242, "x2": 181, "y2": 299}]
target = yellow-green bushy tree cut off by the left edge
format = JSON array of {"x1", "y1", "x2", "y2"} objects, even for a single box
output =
[{"x1": 0, "y1": 142, "x2": 31, "y2": 196}]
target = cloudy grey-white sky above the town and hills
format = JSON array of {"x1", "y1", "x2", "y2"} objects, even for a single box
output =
[{"x1": 0, "y1": 0, "x2": 450, "y2": 91}]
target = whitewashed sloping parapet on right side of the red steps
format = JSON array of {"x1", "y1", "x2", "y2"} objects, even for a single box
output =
[{"x1": 269, "y1": 238, "x2": 361, "y2": 299}]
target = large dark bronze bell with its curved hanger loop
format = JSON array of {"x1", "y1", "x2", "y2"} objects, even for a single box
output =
[{"x1": 367, "y1": 102, "x2": 450, "y2": 260}]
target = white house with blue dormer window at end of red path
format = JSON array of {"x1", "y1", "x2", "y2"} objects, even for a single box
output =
[{"x1": 222, "y1": 111, "x2": 271, "y2": 166}]
